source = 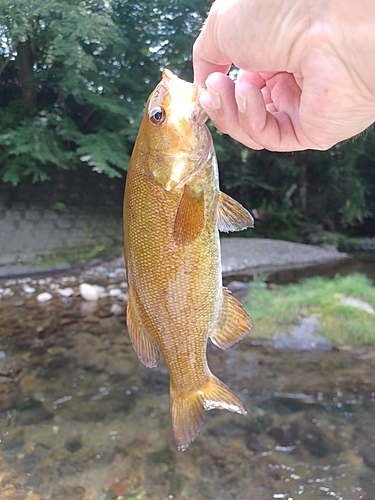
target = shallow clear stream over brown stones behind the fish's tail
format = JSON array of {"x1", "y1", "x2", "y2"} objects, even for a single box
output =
[{"x1": 0, "y1": 256, "x2": 375, "y2": 500}]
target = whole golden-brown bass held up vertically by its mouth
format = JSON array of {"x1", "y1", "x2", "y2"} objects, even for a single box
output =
[{"x1": 124, "y1": 69, "x2": 254, "y2": 451}]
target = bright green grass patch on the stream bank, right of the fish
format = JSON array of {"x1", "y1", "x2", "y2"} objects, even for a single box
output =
[{"x1": 243, "y1": 273, "x2": 375, "y2": 346}]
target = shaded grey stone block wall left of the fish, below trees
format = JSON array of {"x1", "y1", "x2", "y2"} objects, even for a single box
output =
[{"x1": 0, "y1": 168, "x2": 124, "y2": 265}]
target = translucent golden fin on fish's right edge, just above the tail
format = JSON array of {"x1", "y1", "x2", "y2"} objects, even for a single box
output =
[{"x1": 210, "y1": 287, "x2": 253, "y2": 349}]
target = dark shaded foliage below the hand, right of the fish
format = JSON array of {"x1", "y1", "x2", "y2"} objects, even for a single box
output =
[{"x1": 217, "y1": 131, "x2": 375, "y2": 240}]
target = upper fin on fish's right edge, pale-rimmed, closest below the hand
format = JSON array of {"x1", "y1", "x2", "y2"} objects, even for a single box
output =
[{"x1": 217, "y1": 191, "x2": 254, "y2": 233}]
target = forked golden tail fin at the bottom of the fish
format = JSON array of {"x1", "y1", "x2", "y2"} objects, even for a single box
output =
[{"x1": 171, "y1": 375, "x2": 247, "y2": 451}]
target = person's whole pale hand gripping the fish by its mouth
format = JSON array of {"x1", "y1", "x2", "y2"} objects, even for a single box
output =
[{"x1": 193, "y1": 0, "x2": 375, "y2": 151}]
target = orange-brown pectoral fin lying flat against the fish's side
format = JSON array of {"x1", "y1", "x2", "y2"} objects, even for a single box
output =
[{"x1": 173, "y1": 184, "x2": 204, "y2": 245}]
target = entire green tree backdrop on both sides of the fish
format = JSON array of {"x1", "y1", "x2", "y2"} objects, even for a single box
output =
[{"x1": 0, "y1": 0, "x2": 375, "y2": 235}]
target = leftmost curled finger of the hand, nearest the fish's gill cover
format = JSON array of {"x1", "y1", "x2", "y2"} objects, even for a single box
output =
[{"x1": 200, "y1": 73, "x2": 262, "y2": 149}]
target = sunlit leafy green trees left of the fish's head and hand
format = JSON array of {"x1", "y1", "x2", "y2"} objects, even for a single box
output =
[{"x1": 0, "y1": 0, "x2": 210, "y2": 185}]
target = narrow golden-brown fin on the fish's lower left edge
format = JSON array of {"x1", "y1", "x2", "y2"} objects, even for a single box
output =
[{"x1": 126, "y1": 294, "x2": 159, "y2": 368}]
